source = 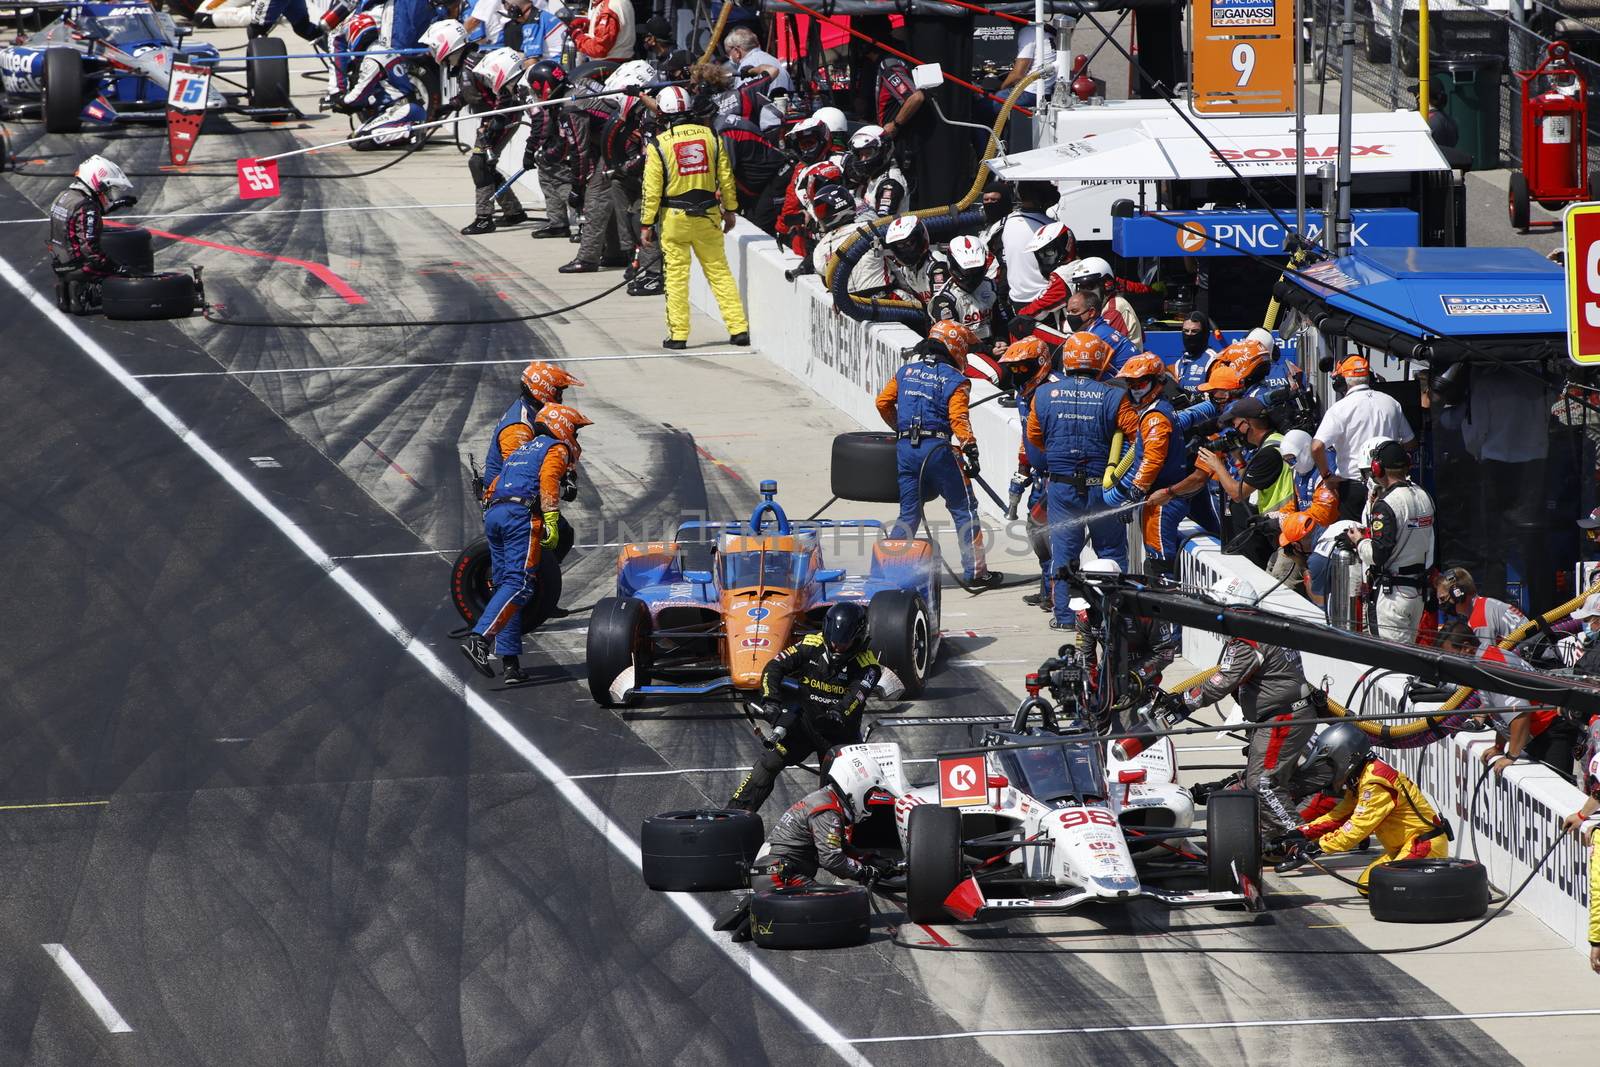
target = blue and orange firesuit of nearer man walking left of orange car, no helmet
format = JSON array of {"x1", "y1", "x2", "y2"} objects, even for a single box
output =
[{"x1": 472, "y1": 434, "x2": 573, "y2": 656}]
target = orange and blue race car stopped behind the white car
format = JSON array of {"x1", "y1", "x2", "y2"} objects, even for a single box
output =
[{"x1": 586, "y1": 482, "x2": 939, "y2": 707}]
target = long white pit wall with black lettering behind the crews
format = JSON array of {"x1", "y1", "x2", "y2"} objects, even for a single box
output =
[{"x1": 681, "y1": 214, "x2": 1589, "y2": 953}]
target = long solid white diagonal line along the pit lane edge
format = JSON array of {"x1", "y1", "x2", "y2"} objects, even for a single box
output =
[{"x1": 0, "y1": 259, "x2": 872, "y2": 1067}]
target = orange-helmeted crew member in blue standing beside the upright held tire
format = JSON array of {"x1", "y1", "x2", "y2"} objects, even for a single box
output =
[{"x1": 878, "y1": 320, "x2": 1002, "y2": 589}]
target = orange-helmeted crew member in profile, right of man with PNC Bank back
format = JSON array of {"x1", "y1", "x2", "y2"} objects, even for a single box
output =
[{"x1": 1106, "y1": 352, "x2": 1187, "y2": 576}]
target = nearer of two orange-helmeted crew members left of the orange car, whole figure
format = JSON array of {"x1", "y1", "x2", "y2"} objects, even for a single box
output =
[{"x1": 461, "y1": 403, "x2": 590, "y2": 685}]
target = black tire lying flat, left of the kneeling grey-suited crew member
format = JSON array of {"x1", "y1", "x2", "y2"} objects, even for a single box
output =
[{"x1": 638, "y1": 808, "x2": 766, "y2": 893}]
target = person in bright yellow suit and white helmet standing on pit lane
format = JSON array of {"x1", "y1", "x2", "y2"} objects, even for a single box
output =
[{"x1": 638, "y1": 85, "x2": 750, "y2": 350}]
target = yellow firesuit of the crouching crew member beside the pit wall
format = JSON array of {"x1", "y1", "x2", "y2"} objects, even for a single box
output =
[{"x1": 1301, "y1": 758, "x2": 1450, "y2": 893}]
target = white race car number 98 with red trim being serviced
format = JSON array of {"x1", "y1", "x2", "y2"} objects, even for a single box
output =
[{"x1": 835, "y1": 702, "x2": 1266, "y2": 923}]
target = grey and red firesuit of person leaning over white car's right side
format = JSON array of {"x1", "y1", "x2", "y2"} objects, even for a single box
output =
[{"x1": 1184, "y1": 637, "x2": 1312, "y2": 840}]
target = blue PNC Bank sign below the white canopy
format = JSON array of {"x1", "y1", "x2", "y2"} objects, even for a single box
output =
[{"x1": 1112, "y1": 208, "x2": 1418, "y2": 258}]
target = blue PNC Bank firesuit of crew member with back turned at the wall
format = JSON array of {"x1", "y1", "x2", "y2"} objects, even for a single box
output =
[{"x1": 1026, "y1": 334, "x2": 1136, "y2": 629}]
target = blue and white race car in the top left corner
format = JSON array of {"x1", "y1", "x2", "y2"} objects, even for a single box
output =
[{"x1": 0, "y1": 2, "x2": 293, "y2": 133}]
